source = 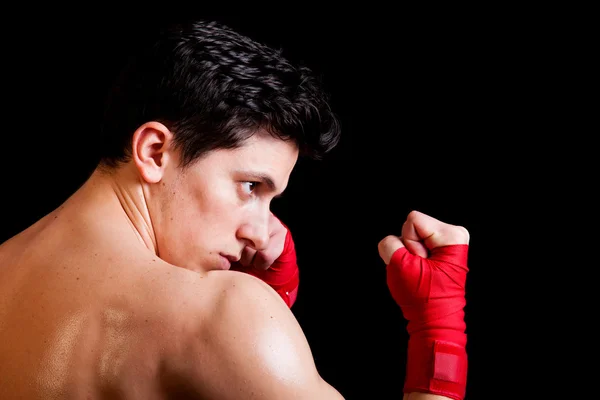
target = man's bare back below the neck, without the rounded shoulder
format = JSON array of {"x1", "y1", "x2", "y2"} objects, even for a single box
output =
[{"x1": 0, "y1": 211, "x2": 232, "y2": 400}]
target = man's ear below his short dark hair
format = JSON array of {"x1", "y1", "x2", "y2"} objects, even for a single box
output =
[{"x1": 131, "y1": 121, "x2": 174, "y2": 183}]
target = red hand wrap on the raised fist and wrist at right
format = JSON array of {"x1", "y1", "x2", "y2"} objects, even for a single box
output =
[{"x1": 386, "y1": 244, "x2": 469, "y2": 400}]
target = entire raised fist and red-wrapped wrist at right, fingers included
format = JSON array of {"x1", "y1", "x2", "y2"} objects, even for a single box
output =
[{"x1": 378, "y1": 211, "x2": 469, "y2": 399}]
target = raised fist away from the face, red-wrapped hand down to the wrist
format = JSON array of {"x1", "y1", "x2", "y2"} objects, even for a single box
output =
[{"x1": 379, "y1": 211, "x2": 469, "y2": 320}]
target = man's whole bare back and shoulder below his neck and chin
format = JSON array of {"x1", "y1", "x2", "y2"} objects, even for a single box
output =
[{"x1": 0, "y1": 206, "x2": 341, "y2": 400}]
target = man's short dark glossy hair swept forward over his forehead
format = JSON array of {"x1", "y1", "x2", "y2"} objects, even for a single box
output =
[{"x1": 100, "y1": 21, "x2": 340, "y2": 166}]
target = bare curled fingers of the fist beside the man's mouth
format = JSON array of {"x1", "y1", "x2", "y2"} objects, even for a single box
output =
[{"x1": 239, "y1": 213, "x2": 288, "y2": 271}]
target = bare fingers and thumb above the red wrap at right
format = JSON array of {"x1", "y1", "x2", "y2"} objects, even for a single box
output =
[{"x1": 377, "y1": 211, "x2": 470, "y2": 265}]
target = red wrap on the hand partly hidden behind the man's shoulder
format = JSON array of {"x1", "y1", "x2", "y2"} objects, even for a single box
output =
[{"x1": 232, "y1": 225, "x2": 300, "y2": 308}]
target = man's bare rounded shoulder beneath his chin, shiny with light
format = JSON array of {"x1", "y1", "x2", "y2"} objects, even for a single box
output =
[{"x1": 165, "y1": 271, "x2": 342, "y2": 399}]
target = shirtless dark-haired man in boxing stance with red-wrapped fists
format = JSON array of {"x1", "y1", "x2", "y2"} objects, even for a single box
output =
[{"x1": 0, "y1": 22, "x2": 468, "y2": 399}]
